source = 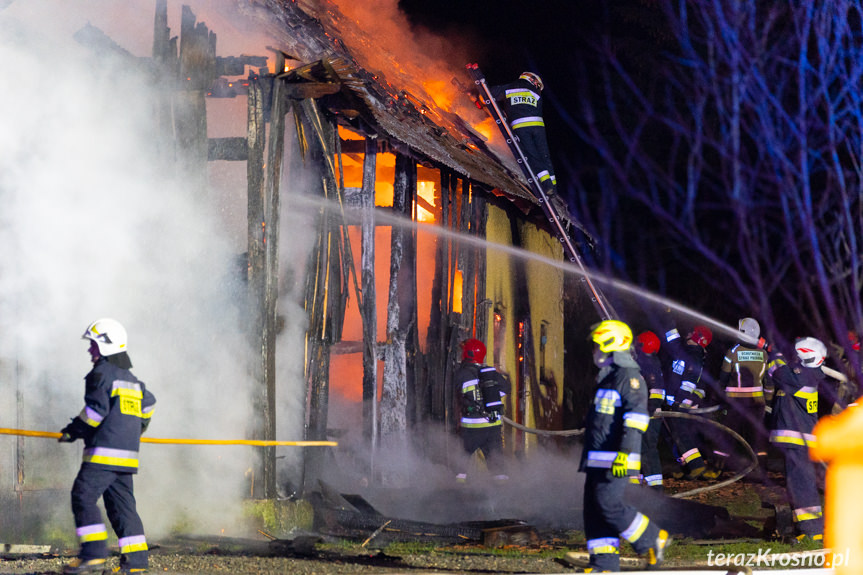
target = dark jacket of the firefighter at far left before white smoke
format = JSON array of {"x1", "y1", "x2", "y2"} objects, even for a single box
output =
[{"x1": 63, "y1": 357, "x2": 156, "y2": 473}]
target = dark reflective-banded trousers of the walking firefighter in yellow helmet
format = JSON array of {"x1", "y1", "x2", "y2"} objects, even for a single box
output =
[{"x1": 584, "y1": 468, "x2": 659, "y2": 571}]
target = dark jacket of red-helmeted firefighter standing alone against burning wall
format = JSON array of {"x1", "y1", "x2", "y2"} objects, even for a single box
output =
[{"x1": 455, "y1": 360, "x2": 509, "y2": 429}]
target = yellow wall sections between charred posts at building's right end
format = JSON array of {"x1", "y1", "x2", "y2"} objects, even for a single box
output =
[{"x1": 486, "y1": 204, "x2": 564, "y2": 456}]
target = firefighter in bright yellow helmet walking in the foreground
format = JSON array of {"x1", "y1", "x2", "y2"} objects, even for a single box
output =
[{"x1": 579, "y1": 320, "x2": 671, "y2": 572}]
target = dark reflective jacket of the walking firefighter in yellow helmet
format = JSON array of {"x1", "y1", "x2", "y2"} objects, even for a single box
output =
[{"x1": 580, "y1": 351, "x2": 650, "y2": 475}]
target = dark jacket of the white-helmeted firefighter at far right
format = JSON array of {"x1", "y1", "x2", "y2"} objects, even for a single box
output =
[{"x1": 768, "y1": 353, "x2": 824, "y2": 448}]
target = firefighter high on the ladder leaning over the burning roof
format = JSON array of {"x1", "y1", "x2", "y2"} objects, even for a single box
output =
[{"x1": 490, "y1": 72, "x2": 557, "y2": 199}]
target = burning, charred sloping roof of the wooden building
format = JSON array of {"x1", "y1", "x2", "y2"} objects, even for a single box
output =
[{"x1": 243, "y1": 0, "x2": 552, "y2": 211}]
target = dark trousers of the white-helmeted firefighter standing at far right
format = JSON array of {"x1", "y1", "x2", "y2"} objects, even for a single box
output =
[{"x1": 782, "y1": 447, "x2": 824, "y2": 538}]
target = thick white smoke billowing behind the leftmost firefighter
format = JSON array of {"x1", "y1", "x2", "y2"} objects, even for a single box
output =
[{"x1": 0, "y1": 0, "x2": 310, "y2": 537}]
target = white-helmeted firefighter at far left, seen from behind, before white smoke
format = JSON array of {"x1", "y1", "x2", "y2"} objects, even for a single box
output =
[{"x1": 59, "y1": 318, "x2": 156, "y2": 573}]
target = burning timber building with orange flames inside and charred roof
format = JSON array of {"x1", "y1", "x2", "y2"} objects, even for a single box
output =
[{"x1": 0, "y1": 0, "x2": 608, "y2": 540}]
